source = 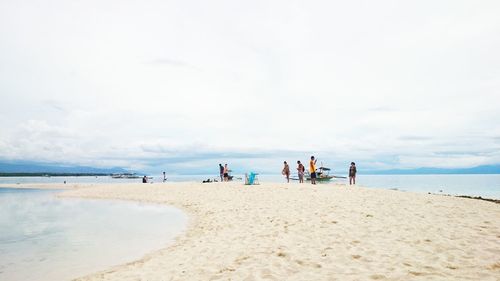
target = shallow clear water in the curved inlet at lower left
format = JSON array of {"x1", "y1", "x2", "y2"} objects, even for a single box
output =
[{"x1": 0, "y1": 188, "x2": 186, "y2": 281}]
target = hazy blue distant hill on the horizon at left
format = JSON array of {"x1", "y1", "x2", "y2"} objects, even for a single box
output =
[{"x1": 0, "y1": 159, "x2": 128, "y2": 174}]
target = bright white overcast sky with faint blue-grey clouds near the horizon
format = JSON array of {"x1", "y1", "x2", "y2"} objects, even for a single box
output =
[{"x1": 0, "y1": 0, "x2": 500, "y2": 174}]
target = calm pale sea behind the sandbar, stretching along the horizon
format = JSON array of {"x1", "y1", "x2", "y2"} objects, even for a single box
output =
[{"x1": 0, "y1": 174, "x2": 500, "y2": 199}]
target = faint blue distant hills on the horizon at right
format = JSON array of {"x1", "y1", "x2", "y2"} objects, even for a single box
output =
[{"x1": 359, "y1": 165, "x2": 500, "y2": 175}]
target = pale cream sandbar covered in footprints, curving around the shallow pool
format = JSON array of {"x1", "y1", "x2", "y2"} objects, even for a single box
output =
[{"x1": 3, "y1": 183, "x2": 500, "y2": 280}]
